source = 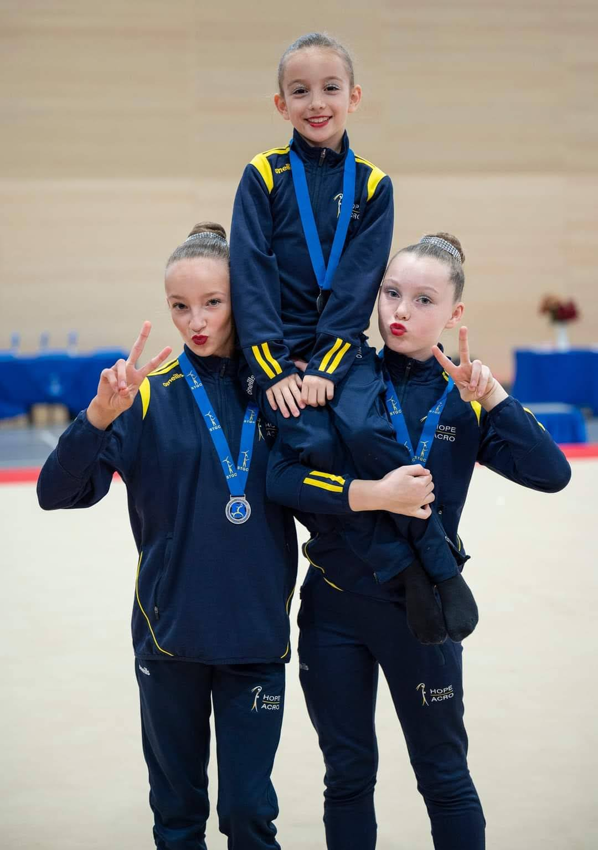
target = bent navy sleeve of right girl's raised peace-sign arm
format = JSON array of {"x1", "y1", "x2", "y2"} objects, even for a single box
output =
[{"x1": 478, "y1": 385, "x2": 571, "y2": 493}]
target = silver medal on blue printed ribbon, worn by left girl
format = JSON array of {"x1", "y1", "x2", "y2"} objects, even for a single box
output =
[{"x1": 179, "y1": 353, "x2": 259, "y2": 525}]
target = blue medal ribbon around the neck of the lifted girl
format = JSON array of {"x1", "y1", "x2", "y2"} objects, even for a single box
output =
[{"x1": 289, "y1": 139, "x2": 355, "y2": 313}]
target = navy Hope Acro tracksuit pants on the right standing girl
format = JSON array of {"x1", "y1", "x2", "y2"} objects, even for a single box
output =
[{"x1": 299, "y1": 568, "x2": 485, "y2": 850}]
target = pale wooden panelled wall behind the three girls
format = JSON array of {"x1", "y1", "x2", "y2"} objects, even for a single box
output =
[{"x1": 0, "y1": 0, "x2": 598, "y2": 376}]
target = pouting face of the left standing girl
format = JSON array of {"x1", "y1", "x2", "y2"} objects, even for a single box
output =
[{"x1": 165, "y1": 257, "x2": 235, "y2": 357}]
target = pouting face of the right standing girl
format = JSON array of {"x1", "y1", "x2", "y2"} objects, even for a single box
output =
[{"x1": 378, "y1": 252, "x2": 464, "y2": 360}]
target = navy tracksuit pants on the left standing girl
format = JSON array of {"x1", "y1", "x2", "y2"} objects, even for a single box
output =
[{"x1": 135, "y1": 659, "x2": 285, "y2": 850}]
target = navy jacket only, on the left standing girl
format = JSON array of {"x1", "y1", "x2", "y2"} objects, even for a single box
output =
[{"x1": 38, "y1": 349, "x2": 304, "y2": 664}]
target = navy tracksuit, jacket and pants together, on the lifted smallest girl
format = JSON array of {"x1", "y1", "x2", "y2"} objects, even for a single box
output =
[{"x1": 231, "y1": 131, "x2": 457, "y2": 581}]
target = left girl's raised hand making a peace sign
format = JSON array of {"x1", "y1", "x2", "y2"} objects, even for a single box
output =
[{"x1": 87, "y1": 322, "x2": 172, "y2": 430}]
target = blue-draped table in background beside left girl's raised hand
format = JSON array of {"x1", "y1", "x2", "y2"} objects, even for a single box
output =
[{"x1": 0, "y1": 349, "x2": 128, "y2": 419}]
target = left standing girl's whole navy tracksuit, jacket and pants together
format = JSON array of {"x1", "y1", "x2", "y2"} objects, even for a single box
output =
[{"x1": 38, "y1": 349, "x2": 346, "y2": 850}]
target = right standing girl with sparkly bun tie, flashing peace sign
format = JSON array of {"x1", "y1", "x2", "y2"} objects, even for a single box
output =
[{"x1": 270, "y1": 233, "x2": 571, "y2": 850}]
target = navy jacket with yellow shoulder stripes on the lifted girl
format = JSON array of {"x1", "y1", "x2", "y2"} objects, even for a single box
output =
[{"x1": 231, "y1": 130, "x2": 393, "y2": 389}]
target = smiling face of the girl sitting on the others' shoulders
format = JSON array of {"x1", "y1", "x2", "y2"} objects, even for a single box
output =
[{"x1": 274, "y1": 47, "x2": 361, "y2": 152}]
